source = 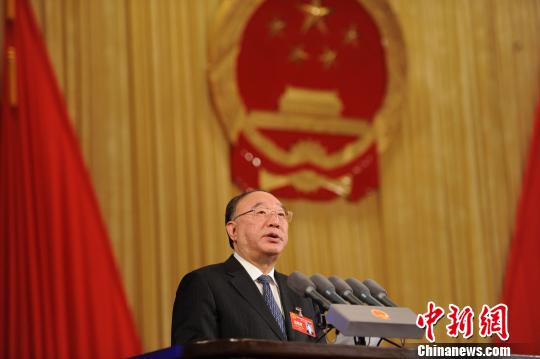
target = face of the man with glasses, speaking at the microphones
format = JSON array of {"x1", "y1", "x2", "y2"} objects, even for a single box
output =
[{"x1": 227, "y1": 192, "x2": 289, "y2": 262}]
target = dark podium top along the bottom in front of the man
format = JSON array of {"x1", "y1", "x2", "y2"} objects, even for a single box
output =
[{"x1": 137, "y1": 339, "x2": 418, "y2": 359}]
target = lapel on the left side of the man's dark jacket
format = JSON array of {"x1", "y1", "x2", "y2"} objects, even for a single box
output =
[{"x1": 225, "y1": 256, "x2": 288, "y2": 340}]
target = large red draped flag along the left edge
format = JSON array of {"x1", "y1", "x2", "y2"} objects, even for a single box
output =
[{"x1": 0, "y1": 0, "x2": 141, "y2": 358}]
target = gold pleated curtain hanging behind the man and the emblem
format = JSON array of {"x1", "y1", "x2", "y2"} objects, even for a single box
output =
[{"x1": 1, "y1": 0, "x2": 540, "y2": 351}]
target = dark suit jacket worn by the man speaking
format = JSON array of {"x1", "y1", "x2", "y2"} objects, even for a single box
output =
[{"x1": 171, "y1": 256, "x2": 316, "y2": 344}]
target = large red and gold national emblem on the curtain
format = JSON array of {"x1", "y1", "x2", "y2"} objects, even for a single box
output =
[{"x1": 209, "y1": 0, "x2": 405, "y2": 201}]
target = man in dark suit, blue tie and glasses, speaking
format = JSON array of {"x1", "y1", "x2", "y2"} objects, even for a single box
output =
[{"x1": 171, "y1": 191, "x2": 316, "y2": 344}]
